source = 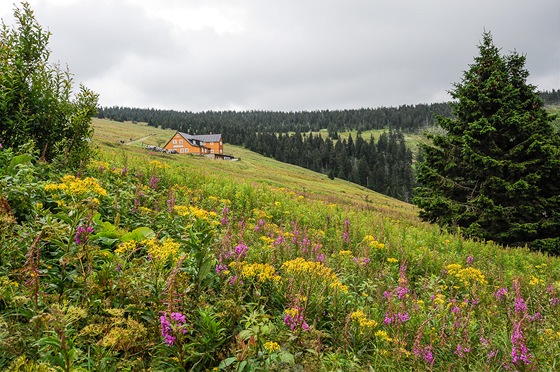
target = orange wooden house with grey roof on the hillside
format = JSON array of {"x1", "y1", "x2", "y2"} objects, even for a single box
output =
[{"x1": 163, "y1": 132, "x2": 224, "y2": 156}]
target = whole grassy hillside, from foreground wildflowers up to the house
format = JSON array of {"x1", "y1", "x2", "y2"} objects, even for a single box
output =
[{"x1": 0, "y1": 120, "x2": 560, "y2": 371}]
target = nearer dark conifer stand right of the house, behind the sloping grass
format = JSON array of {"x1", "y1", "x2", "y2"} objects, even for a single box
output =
[{"x1": 243, "y1": 131, "x2": 414, "y2": 201}]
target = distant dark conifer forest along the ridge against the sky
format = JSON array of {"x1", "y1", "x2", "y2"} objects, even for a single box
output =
[{"x1": 98, "y1": 103, "x2": 451, "y2": 134}]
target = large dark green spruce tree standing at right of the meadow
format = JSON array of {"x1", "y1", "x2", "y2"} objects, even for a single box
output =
[{"x1": 415, "y1": 32, "x2": 560, "y2": 254}]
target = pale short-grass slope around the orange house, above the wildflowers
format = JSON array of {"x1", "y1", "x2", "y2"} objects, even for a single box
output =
[{"x1": 93, "y1": 119, "x2": 417, "y2": 220}]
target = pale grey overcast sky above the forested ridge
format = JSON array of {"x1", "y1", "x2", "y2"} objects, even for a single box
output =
[{"x1": 0, "y1": 0, "x2": 560, "y2": 111}]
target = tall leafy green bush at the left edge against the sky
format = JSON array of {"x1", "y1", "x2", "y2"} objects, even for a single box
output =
[{"x1": 0, "y1": 3, "x2": 98, "y2": 166}]
